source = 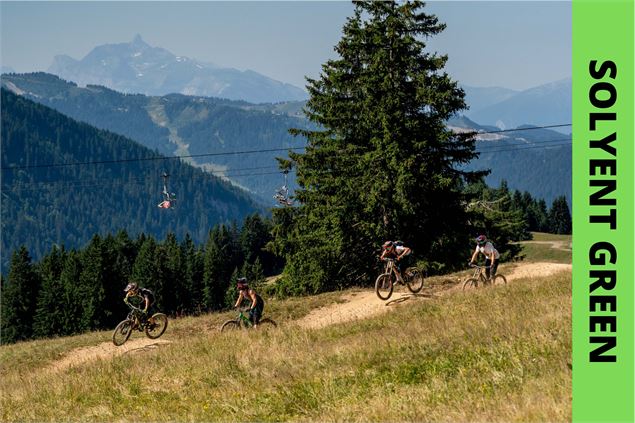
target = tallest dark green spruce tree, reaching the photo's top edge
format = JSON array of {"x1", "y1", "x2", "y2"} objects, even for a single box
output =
[{"x1": 277, "y1": 1, "x2": 483, "y2": 293}]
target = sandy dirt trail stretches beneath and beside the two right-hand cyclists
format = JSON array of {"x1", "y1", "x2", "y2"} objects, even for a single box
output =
[{"x1": 296, "y1": 262, "x2": 571, "y2": 329}]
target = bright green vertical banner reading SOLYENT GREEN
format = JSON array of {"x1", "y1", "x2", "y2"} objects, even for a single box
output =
[{"x1": 572, "y1": 0, "x2": 635, "y2": 422}]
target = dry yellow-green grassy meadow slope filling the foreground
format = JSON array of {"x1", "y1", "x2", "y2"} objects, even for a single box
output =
[{"x1": 0, "y1": 238, "x2": 571, "y2": 422}]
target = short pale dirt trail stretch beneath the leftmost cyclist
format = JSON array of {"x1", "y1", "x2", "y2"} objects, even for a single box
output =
[{"x1": 50, "y1": 337, "x2": 170, "y2": 371}]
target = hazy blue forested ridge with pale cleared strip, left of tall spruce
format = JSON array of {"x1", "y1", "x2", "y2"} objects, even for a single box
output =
[{"x1": 2, "y1": 72, "x2": 308, "y2": 204}]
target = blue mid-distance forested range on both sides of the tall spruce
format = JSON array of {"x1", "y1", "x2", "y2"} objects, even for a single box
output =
[{"x1": 2, "y1": 73, "x2": 571, "y2": 210}]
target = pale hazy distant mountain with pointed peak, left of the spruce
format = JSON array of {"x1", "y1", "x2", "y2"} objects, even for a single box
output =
[{"x1": 48, "y1": 35, "x2": 307, "y2": 103}]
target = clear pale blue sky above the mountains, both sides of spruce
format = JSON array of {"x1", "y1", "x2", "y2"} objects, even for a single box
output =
[{"x1": 0, "y1": 1, "x2": 571, "y2": 90}]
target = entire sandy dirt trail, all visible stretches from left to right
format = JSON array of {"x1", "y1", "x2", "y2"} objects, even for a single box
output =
[{"x1": 49, "y1": 262, "x2": 571, "y2": 371}]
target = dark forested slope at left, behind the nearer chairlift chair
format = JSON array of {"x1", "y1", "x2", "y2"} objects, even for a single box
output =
[{"x1": 2, "y1": 89, "x2": 261, "y2": 271}]
